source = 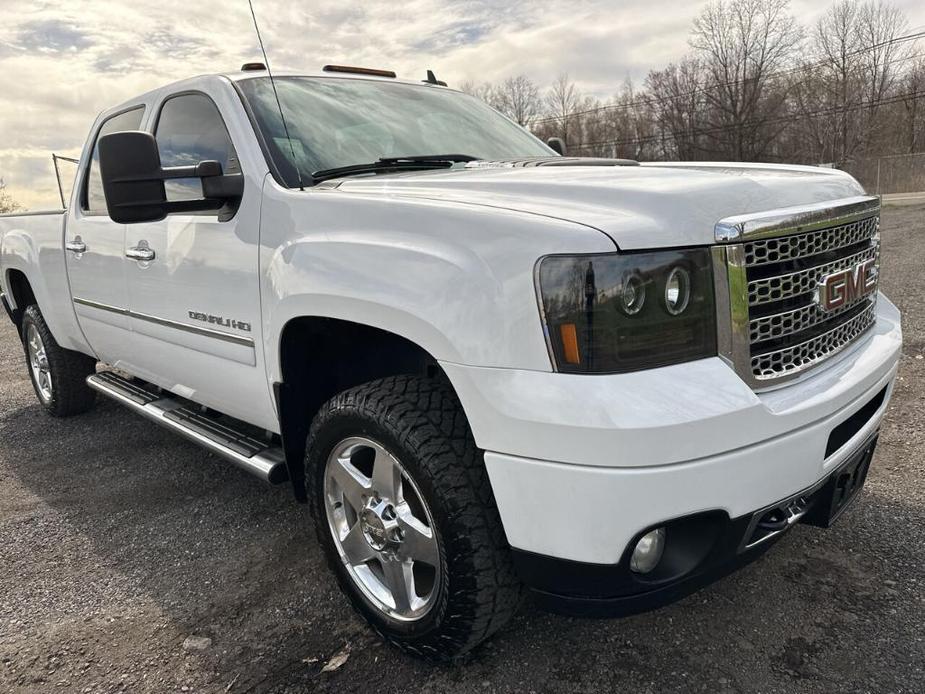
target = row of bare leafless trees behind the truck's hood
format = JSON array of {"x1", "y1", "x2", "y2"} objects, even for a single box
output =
[{"x1": 463, "y1": 0, "x2": 925, "y2": 167}]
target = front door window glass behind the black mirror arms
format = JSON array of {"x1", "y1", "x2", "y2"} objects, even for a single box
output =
[{"x1": 155, "y1": 94, "x2": 241, "y2": 202}]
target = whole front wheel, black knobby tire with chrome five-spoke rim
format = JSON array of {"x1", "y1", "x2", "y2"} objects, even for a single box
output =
[{"x1": 306, "y1": 376, "x2": 522, "y2": 661}]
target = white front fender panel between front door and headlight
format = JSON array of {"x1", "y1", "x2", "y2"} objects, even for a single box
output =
[{"x1": 261, "y1": 186, "x2": 614, "y2": 380}]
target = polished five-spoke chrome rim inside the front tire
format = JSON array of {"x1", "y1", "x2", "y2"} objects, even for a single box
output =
[{"x1": 324, "y1": 437, "x2": 443, "y2": 622}]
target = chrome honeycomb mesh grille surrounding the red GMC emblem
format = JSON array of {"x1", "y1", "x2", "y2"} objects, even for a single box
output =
[{"x1": 714, "y1": 197, "x2": 880, "y2": 389}]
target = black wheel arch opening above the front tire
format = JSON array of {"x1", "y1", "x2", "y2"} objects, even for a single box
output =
[{"x1": 273, "y1": 316, "x2": 456, "y2": 501}]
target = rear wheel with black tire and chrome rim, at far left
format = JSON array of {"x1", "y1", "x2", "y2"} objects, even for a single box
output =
[{"x1": 22, "y1": 304, "x2": 96, "y2": 417}]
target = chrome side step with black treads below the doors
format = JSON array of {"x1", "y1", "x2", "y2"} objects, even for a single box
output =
[{"x1": 87, "y1": 371, "x2": 289, "y2": 484}]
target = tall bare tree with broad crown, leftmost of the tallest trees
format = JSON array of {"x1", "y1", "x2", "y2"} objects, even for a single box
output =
[{"x1": 691, "y1": 0, "x2": 800, "y2": 161}]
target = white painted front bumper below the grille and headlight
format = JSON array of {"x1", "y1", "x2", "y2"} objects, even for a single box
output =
[{"x1": 443, "y1": 296, "x2": 902, "y2": 566}]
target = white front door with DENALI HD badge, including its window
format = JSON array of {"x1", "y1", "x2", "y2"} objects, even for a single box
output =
[{"x1": 119, "y1": 91, "x2": 273, "y2": 428}]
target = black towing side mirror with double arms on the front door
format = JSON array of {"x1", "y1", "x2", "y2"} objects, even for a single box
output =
[{"x1": 99, "y1": 131, "x2": 244, "y2": 224}]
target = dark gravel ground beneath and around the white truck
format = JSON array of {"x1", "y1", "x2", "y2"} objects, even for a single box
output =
[{"x1": 0, "y1": 205, "x2": 925, "y2": 693}]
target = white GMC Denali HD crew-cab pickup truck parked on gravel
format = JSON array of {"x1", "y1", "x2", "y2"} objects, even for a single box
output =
[{"x1": 0, "y1": 65, "x2": 902, "y2": 659}]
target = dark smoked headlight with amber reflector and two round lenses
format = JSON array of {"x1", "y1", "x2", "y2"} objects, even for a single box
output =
[{"x1": 537, "y1": 248, "x2": 716, "y2": 373}]
